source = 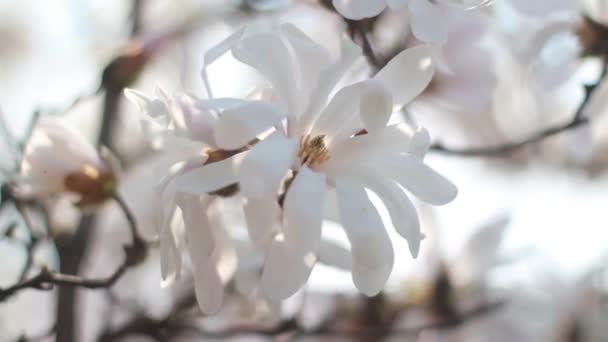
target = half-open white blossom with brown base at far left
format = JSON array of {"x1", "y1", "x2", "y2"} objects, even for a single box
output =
[{"x1": 18, "y1": 117, "x2": 118, "y2": 206}]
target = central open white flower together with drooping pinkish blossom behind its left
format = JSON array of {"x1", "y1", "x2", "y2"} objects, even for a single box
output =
[{"x1": 127, "y1": 24, "x2": 457, "y2": 312}]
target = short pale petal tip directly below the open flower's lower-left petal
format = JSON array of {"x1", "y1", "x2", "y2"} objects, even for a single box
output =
[{"x1": 243, "y1": 196, "x2": 280, "y2": 247}]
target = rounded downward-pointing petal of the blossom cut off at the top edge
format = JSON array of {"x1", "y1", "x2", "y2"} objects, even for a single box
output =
[{"x1": 409, "y1": 0, "x2": 448, "y2": 45}]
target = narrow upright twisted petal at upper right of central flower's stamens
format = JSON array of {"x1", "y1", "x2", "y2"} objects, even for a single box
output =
[{"x1": 296, "y1": 35, "x2": 362, "y2": 136}]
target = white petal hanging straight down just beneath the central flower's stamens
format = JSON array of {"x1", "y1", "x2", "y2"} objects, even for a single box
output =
[{"x1": 283, "y1": 166, "x2": 325, "y2": 255}]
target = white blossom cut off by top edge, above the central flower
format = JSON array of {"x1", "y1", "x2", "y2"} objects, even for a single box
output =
[{"x1": 333, "y1": 0, "x2": 490, "y2": 44}]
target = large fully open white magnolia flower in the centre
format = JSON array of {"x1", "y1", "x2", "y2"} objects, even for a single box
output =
[{"x1": 158, "y1": 25, "x2": 457, "y2": 300}]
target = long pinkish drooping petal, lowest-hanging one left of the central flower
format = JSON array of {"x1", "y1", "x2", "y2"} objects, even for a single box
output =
[{"x1": 178, "y1": 196, "x2": 224, "y2": 314}]
